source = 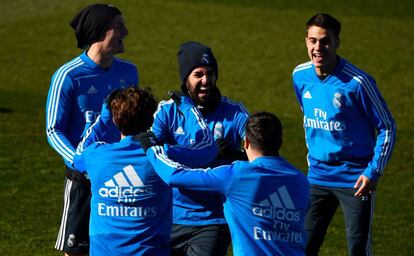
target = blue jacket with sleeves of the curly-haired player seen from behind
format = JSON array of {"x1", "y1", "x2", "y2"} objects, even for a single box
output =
[{"x1": 74, "y1": 98, "x2": 217, "y2": 255}]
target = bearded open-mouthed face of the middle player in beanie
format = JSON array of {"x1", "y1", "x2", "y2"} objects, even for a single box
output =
[{"x1": 186, "y1": 66, "x2": 217, "y2": 105}]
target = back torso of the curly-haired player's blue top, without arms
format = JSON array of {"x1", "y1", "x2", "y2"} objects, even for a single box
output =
[{"x1": 75, "y1": 136, "x2": 171, "y2": 255}]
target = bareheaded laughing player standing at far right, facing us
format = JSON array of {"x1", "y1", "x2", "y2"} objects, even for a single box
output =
[{"x1": 293, "y1": 13, "x2": 396, "y2": 255}]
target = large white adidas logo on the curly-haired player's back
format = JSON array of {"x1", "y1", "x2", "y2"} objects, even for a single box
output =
[{"x1": 99, "y1": 165, "x2": 152, "y2": 198}]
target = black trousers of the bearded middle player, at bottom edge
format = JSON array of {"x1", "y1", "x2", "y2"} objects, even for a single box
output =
[{"x1": 170, "y1": 224, "x2": 231, "y2": 256}]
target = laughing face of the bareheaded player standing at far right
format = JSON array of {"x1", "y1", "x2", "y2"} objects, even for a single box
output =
[{"x1": 305, "y1": 26, "x2": 339, "y2": 76}]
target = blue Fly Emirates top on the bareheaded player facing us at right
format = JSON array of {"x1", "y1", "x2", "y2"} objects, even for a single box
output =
[{"x1": 293, "y1": 58, "x2": 396, "y2": 188}]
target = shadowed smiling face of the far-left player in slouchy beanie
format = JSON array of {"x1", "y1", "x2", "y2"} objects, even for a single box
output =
[{"x1": 102, "y1": 15, "x2": 128, "y2": 55}]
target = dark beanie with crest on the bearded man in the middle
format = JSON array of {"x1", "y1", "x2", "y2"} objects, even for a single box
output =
[{"x1": 177, "y1": 41, "x2": 218, "y2": 84}]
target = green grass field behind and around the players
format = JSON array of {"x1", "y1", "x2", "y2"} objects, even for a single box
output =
[{"x1": 0, "y1": 0, "x2": 414, "y2": 255}]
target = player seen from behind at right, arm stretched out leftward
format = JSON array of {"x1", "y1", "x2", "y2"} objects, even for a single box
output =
[{"x1": 141, "y1": 112, "x2": 309, "y2": 256}]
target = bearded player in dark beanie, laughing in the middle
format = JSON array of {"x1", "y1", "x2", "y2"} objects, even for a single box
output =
[{"x1": 151, "y1": 41, "x2": 248, "y2": 256}]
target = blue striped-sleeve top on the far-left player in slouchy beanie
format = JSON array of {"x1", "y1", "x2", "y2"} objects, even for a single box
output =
[{"x1": 46, "y1": 52, "x2": 139, "y2": 166}]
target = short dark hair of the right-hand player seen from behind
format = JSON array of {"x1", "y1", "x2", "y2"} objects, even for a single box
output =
[{"x1": 246, "y1": 112, "x2": 282, "y2": 155}]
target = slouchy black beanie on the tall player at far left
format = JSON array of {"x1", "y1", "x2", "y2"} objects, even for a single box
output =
[{"x1": 70, "y1": 4, "x2": 121, "y2": 49}]
